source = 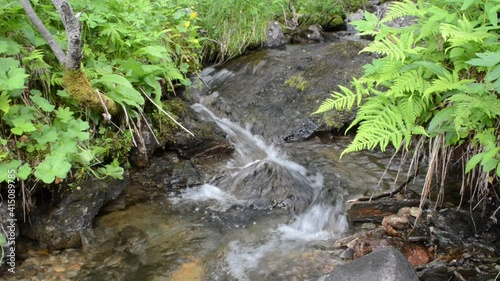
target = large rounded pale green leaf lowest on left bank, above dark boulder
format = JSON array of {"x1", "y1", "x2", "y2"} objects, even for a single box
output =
[{"x1": 35, "y1": 155, "x2": 71, "y2": 184}]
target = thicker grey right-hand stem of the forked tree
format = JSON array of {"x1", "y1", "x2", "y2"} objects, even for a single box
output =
[{"x1": 52, "y1": 0, "x2": 83, "y2": 70}]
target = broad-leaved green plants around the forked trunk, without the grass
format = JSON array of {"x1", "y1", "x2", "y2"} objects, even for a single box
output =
[{"x1": 0, "y1": 0, "x2": 201, "y2": 193}]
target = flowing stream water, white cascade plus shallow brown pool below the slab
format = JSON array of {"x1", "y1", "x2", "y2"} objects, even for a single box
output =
[{"x1": 13, "y1": 101, "x2": 408, "y2": 280}]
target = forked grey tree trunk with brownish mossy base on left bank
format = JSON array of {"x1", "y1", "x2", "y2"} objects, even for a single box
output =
[{"x1": 20, "y1": 0, "x2": 118, "y2": 114}]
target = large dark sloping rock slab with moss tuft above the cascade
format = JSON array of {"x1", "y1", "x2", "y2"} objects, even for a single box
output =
[{"x1": 189, "y1": 41, "x2": 372, "y2": 142}]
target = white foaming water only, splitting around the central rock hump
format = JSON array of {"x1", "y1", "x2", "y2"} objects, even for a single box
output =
[{"x1": 173, "y1": 104, "x2": 348, "y2": 280}]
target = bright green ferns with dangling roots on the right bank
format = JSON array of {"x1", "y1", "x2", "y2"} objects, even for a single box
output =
[{"x1": 316, "y1": 0, "x2": 500, "y2": 210}]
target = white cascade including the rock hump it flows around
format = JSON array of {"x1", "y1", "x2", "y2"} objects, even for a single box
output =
[{"x1": 174, "y1": 104, "x2": 347, "y2": 281}]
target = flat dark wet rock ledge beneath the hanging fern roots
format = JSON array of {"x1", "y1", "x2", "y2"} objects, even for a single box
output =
[{"x1": 348, "y1": 199, "x2": 420, "y2": 222}]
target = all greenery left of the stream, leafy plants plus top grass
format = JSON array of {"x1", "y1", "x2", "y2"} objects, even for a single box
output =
[{"x1": 0, "y1": 0, "x2": 372, "y2": 197}]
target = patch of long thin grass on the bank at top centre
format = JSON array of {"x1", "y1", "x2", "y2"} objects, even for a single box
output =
[{"x1": 195, "y1": 0, "x2": 367, "y2": 63}]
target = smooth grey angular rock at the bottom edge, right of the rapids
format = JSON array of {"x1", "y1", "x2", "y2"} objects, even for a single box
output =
[{"x1": 318, "y1": 247, "x2": 418, "y2": 281}]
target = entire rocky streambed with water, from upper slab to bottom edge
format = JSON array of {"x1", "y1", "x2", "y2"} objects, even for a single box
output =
[{"x1": 0, "y1": 37, "x2": 500, "y2": 280}]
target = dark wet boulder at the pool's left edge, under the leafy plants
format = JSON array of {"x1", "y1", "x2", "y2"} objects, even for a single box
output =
[{"x1": 21, "y1": 177, "x2": 127, "y2": 250}]
